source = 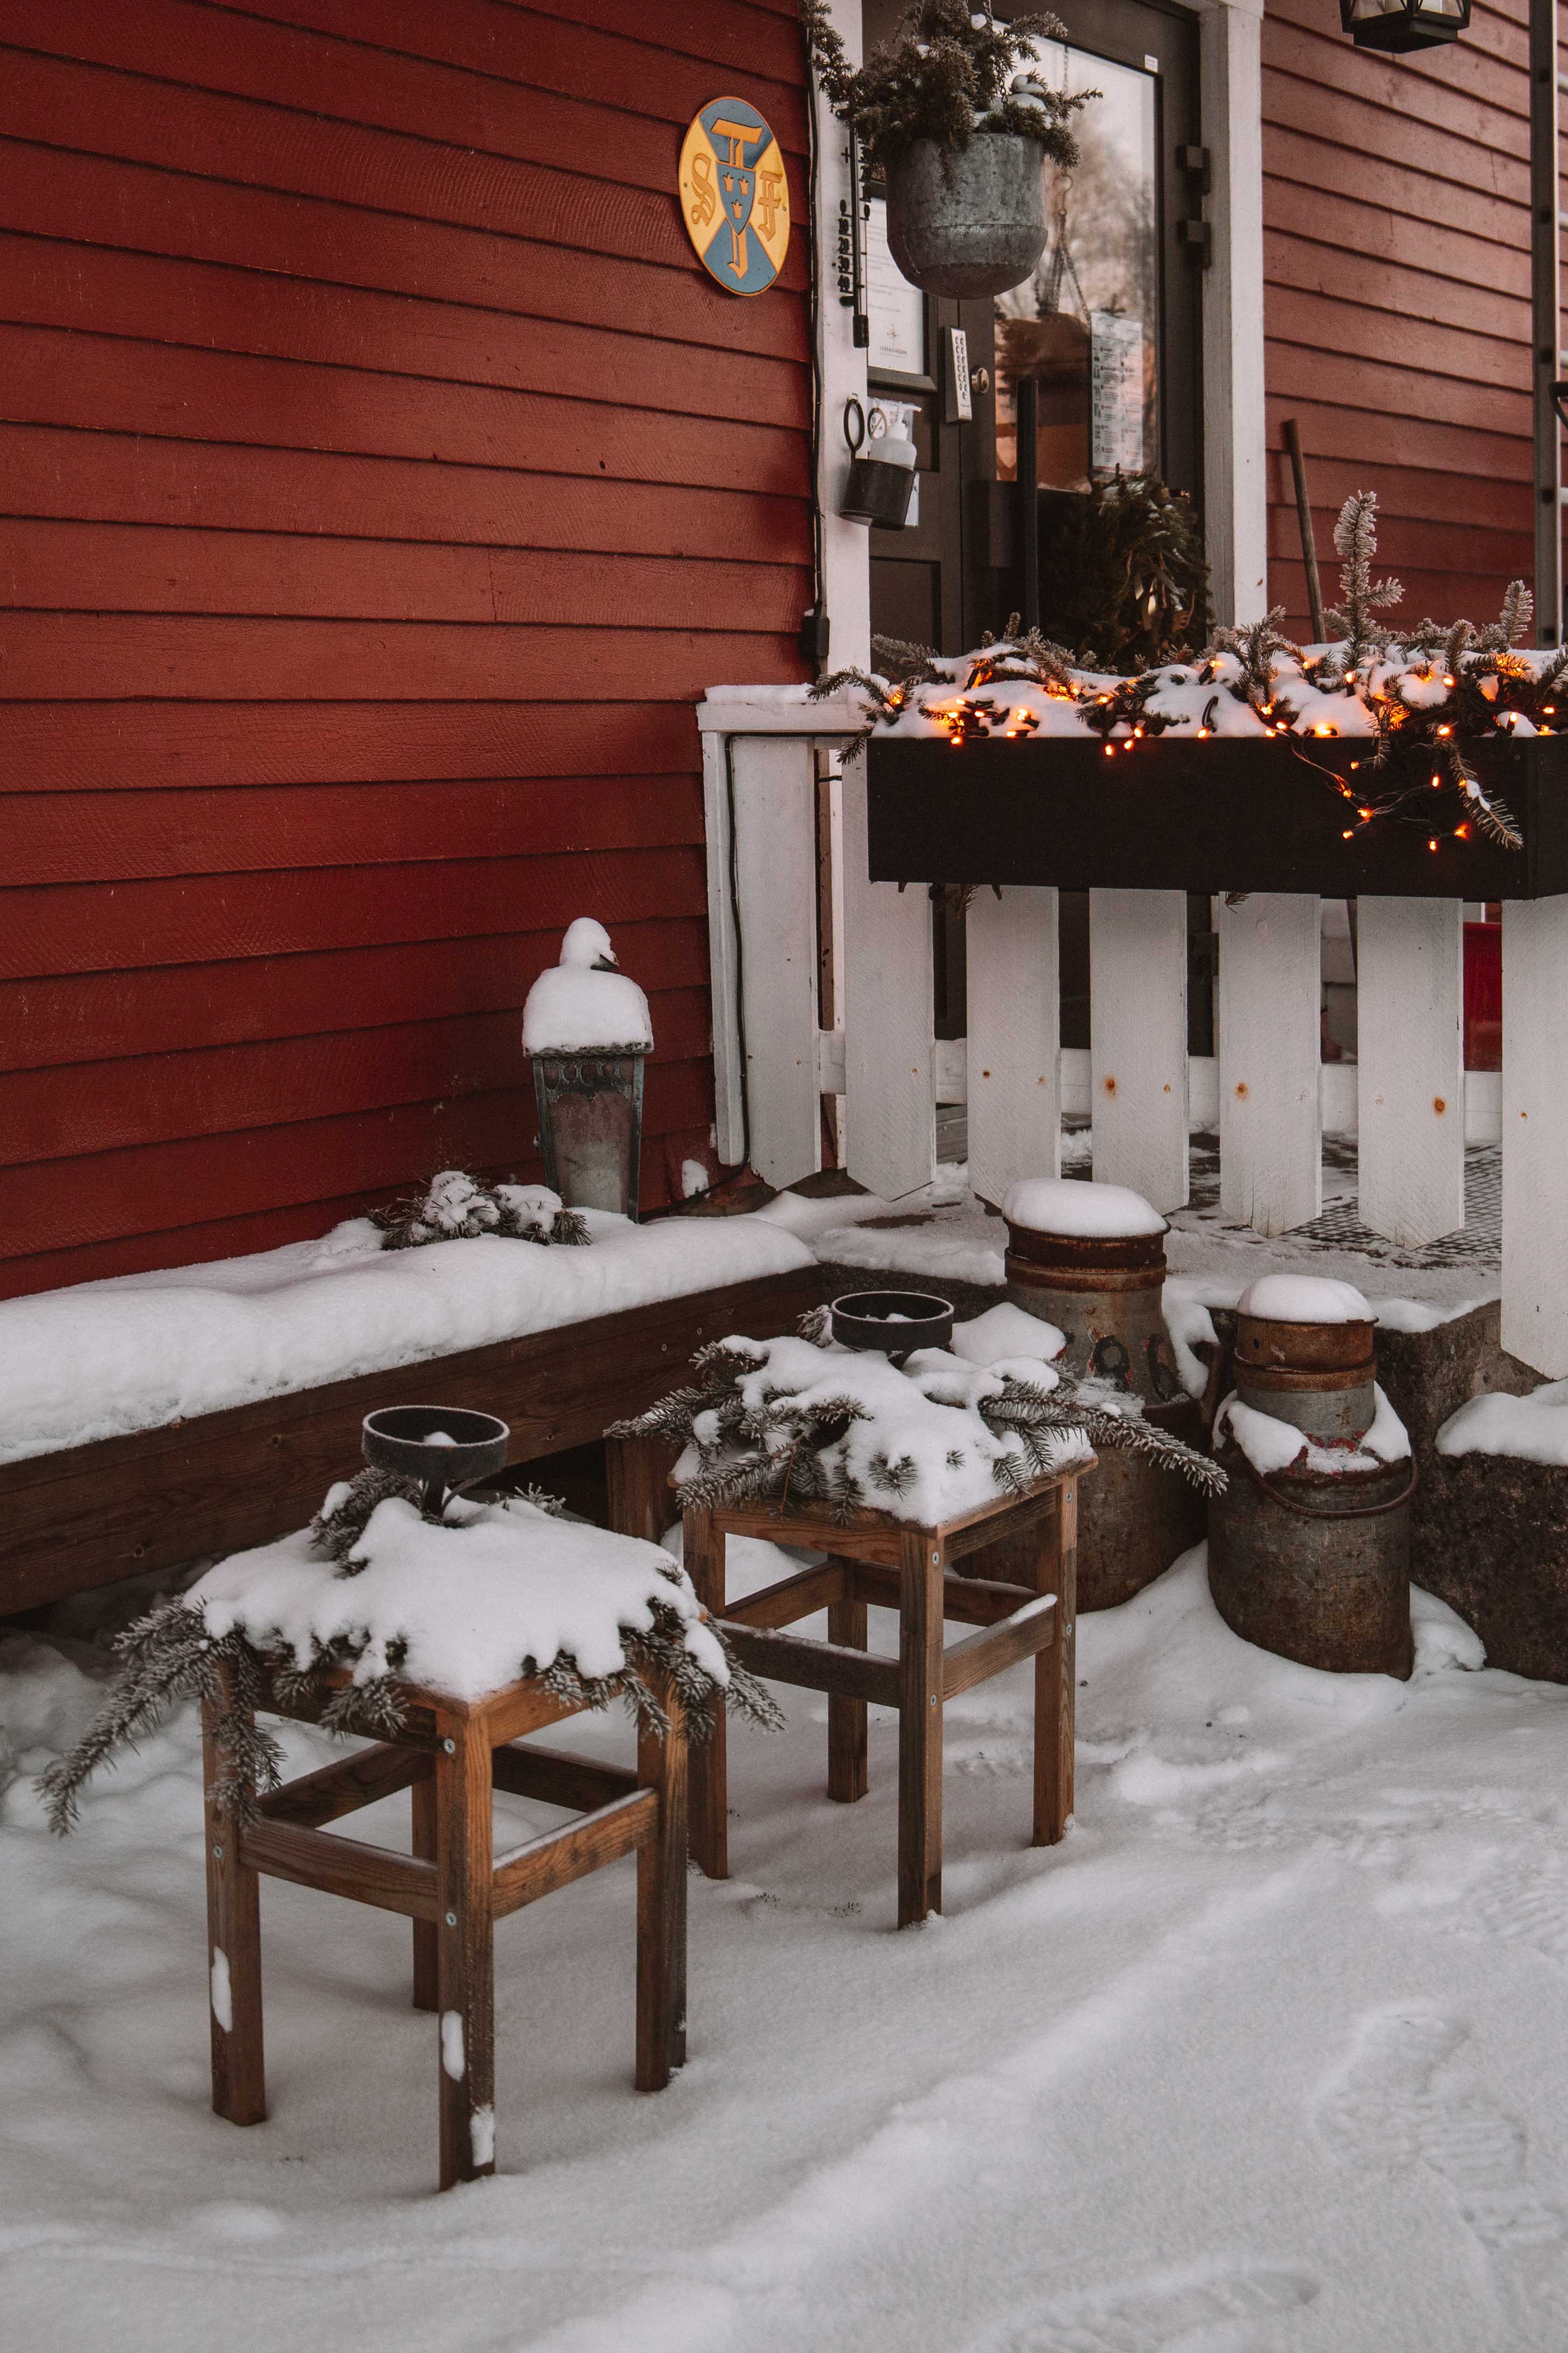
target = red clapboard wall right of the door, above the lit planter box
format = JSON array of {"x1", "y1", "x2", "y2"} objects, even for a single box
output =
[{"x1": 1262, "y1": 0, "x2": 1535, "y2": 633}]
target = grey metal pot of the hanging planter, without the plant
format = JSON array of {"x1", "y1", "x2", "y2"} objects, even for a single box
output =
[{"x1": 886, "y1": 132, "x2": 1046, "y2": 299}]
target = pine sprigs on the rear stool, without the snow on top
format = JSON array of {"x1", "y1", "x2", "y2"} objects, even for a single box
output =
[{"x1": 609, "y1": 1308, "x2": 1225, "y2": 1522}]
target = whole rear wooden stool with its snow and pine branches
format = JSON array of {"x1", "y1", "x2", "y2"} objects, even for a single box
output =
[{"x1": 611, "y1": 1311, "x2": 1220, "y2": 1927}]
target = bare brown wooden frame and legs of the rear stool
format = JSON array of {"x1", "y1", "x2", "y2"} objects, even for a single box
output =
[{"x1": 686, "y1": 1463, "x2": 1088, "y2": 1927}]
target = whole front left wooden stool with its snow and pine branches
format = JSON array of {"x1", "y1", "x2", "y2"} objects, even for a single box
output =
[{"x1": 45, "y1": 1470, "x2": 778, "y2": 2188}]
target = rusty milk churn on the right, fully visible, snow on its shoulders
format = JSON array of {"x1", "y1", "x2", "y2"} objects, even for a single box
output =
[{"x1": 1208, "y1": 1276, "x2": 1415, "y2": 1678}]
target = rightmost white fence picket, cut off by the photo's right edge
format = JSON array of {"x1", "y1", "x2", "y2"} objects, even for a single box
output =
[{"x1": 1502, "y1": 899, "x2": 1568, "y2": 1381}]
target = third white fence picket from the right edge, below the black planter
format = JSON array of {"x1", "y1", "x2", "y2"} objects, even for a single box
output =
[{"x1": 1222, "y1": 892, "x2": 1324, "y2": 1233}]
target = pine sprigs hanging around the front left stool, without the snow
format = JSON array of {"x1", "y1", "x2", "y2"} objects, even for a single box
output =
[{"x1": 38, "y1": 1470, "x2": 783, "y2": 1838}]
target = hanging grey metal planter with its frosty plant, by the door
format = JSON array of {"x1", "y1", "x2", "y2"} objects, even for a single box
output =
[{"x1": 801, "y1": 0, "x2": 1098, "y2": 297}]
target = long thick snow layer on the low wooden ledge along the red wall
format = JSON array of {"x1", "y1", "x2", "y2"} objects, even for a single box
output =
[{"x1": 0, "y1": 1209, "x2": 811, "y2": 1461}]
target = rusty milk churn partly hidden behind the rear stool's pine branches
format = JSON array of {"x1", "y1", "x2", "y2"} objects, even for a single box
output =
[{"x1": 1004, "y1": 1176, "x2": 1204, "y2": 1609}]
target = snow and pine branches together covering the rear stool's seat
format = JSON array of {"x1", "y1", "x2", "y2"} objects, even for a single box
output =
[{"x1": 611, "y1": 1308, "x2": 1225, "y2": 1527}]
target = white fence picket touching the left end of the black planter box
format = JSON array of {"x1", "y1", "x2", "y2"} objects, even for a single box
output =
[{"x1": 844, "y1": 760, "x2": 936, "y2": 1200}]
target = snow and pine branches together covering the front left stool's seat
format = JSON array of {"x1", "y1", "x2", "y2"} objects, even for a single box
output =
[{"x1": 38, "y1": 1470, "x2": 783, "y2": 1836}]
